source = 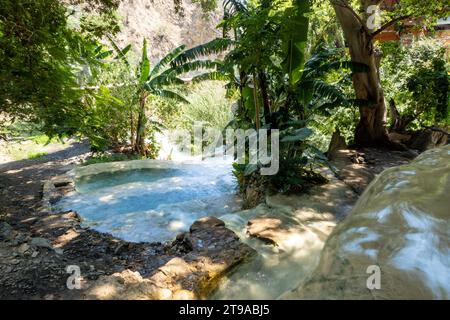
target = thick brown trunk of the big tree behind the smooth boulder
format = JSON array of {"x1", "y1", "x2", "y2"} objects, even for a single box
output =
[{"x1": 333, "y1": 1, "x2": 389, "y2": 146}]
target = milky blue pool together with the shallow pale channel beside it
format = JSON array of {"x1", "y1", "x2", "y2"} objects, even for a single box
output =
[{"x1": 57, "y1": 136, "x2": 356, "y2": 299}]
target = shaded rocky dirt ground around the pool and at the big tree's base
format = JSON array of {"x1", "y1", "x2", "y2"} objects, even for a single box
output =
[{"x1": 0, "y1": 139, "x2": 416, "y2": 299}]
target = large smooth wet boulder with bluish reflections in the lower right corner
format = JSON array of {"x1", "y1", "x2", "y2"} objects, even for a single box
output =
[{"x1": 284, "y1": 146, "x2": 450, "y2": 299}]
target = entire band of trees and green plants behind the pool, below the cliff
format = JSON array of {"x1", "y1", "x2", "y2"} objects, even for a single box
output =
[{"x1": 0, "y1": 0, "x2": 450, "y2": 198}]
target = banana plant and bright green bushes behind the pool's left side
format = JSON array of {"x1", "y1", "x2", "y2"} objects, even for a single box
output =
[{"x1": 72, "y1": 36, "x2": 225, "y2": 158}]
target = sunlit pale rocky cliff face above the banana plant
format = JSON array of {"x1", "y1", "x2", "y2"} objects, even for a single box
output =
[{"x1": 116, "y1": 0, "x2": 222, "y2": 60}]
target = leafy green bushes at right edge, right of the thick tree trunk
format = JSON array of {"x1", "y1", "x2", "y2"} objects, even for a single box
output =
[{"x1": 382, "y1": 39, "x2": 450, "y2": 128}]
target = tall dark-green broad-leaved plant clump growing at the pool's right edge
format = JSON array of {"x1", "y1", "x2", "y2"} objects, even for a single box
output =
[{"x1": 220, "y1": 1, "x2": 348, "y2": 191}]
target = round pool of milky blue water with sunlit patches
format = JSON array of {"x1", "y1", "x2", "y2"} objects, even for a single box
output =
[{"x1": 57, "y1": 159, "x2": 240, "y2": 242}]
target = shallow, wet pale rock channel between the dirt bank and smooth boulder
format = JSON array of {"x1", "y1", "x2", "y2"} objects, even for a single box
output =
[{"x1": 212, "y1": 170, "x2": 357, "y2": 299}]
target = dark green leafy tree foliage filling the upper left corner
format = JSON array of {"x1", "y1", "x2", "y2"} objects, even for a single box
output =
[{"x1": 0, "y1": 0, "x2": 117, "y2": 136}]
